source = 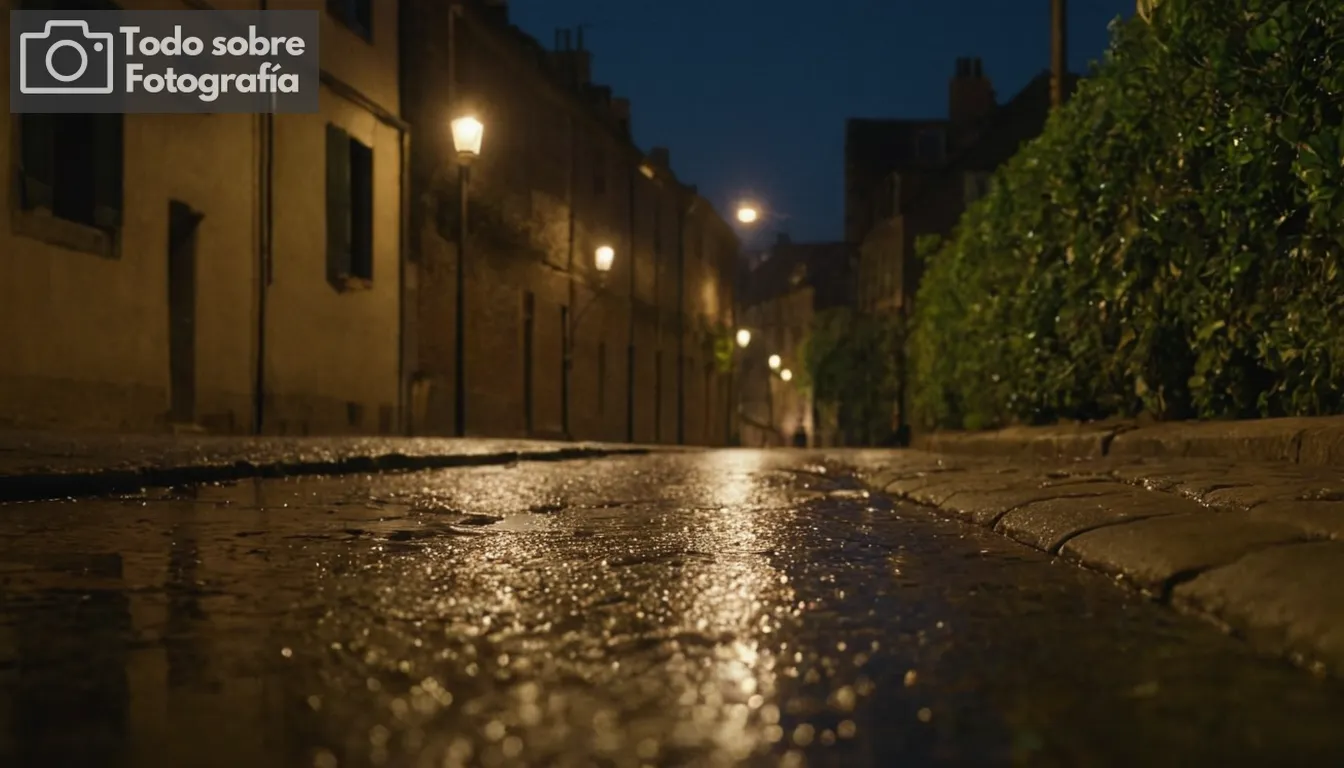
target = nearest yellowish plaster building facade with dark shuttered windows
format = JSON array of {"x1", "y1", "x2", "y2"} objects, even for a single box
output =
[{"x1": 0, "y1": 0, "x2": 405, "y2": 433}]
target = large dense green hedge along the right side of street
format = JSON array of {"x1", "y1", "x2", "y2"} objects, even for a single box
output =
[{"x1": 910, "y1": 0, "x2": 1344, "y2": 429}]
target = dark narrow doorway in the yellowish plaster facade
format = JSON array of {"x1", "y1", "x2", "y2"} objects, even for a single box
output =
[{"x1": 168, "y1": 200, "x2": 204, "y2": 424}]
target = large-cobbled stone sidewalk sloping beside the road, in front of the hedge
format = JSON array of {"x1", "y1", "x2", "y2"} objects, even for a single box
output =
[{"x1": 841, "y1": 451, "x2": 1344, "y2": 677}]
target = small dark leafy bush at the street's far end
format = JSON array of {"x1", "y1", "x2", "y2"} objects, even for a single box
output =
[{"x1": 797, "y1": 308, "x2": 903, "y2": 445}]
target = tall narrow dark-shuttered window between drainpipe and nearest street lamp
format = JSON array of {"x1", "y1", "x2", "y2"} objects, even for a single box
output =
[{"x1": 327, "y1": 124, "x2": 374, "y2": 289}]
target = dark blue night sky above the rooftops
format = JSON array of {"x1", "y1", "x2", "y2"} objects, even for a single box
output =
[{"x1": 509, "y1": 0, "x2": 1134, "y2": 242}]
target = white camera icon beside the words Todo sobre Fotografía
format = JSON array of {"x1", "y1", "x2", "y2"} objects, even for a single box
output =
[{"x1": 19, "y1": 19, "x2": 113, "y2": 94}]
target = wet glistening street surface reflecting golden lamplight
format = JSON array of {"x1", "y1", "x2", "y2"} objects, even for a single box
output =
[{"x1": 0, "y1": 451, "x2": 1344, "y2": 768}]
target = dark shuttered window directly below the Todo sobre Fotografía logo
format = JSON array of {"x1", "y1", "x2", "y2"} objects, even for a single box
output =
[{"x1": 19, "y1": 114, "x2": 125, "y2": 231}]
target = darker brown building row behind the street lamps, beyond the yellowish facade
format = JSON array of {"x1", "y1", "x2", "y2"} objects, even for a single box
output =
[{"x1": 403, "y1": 1, "x2": 738, "y2": 444}]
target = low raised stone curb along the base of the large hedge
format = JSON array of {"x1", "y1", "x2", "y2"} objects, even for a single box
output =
[{"x1": 915, "y1": 416, "x2": 1344, "y2": 467}]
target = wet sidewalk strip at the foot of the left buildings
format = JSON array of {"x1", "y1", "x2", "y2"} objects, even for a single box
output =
[{"x1": 0, "y1": 432, "x2": 650, "y2": 502}]
